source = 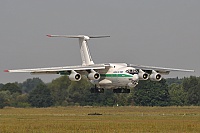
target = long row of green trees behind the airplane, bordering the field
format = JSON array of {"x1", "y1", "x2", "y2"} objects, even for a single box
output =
[{"x1": 0, "y1": 76, "x2": 200, "y2": 108}]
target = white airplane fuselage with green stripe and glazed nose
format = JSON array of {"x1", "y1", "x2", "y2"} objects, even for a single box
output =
[{"x1": 91, "y1": 63, "x2": 139, "y2": 88}]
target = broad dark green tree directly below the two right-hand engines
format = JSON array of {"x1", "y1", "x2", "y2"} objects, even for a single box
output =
[{"x1": 134, "y1": 79, "x2": 169, "y2": 106}]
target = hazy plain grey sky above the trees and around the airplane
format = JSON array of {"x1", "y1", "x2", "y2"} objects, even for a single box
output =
[{"x1": 0, "y1": 0, "x2": 200, "y2": 83}]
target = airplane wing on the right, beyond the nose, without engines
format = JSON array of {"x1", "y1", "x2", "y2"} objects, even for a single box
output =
[{"x1": 128, "y1": 64, "x2": 194, "y2": 74}]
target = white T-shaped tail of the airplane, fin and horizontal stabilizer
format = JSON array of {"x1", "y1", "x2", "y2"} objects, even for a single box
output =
[{"x1": 47, "y1": 35, "x2": 110, "y2": 66}]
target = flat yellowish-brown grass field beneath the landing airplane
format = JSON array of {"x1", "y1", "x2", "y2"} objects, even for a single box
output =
[{"x1": 0, "y1": 106, "x2": 200, "y2": 133}]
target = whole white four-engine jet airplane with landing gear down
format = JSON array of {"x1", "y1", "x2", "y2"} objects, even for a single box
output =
[{"x1": 4, "y1": 35, "x2": 194, "y2": 93}]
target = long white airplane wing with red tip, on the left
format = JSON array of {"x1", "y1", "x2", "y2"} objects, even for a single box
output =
[{"x1": 4, "y1": 64, "x2": 105, "y2": 74}]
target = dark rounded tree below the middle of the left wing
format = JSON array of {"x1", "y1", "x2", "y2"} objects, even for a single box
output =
[{"x1": 28, "y1": 84, "x2": 53, "y2": 107}]
